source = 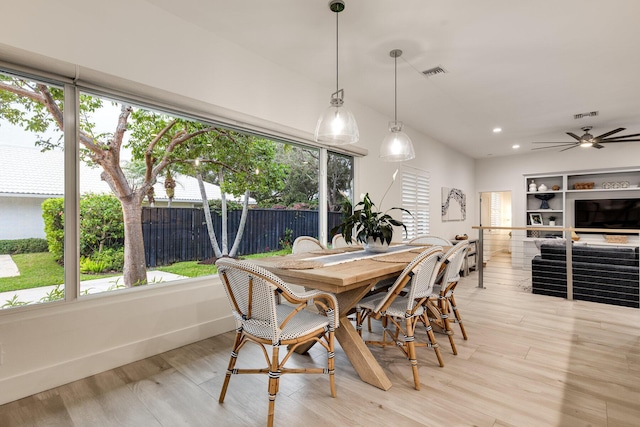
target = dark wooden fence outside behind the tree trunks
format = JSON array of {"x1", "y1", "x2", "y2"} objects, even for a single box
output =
[{"x1": 142, "y1": 208, "x2": 342, "y2": 267}]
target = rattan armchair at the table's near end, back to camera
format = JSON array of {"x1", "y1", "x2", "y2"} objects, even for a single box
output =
[{"x1": 216, "y1": 258, "x2": 339, "y2": 426}]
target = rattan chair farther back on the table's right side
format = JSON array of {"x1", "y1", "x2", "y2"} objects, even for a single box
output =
[{"x1": 429, "y1": 240, "x2": 469, "y2": 354}]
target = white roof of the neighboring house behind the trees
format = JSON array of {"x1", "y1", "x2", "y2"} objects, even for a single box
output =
[{"x1": 0, "y1": 145, "x2": 255, "y2": 204}]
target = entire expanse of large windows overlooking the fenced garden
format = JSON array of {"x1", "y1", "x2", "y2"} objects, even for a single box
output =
[{"x1": 0, "y1": 67, "x2": 353, "y2": 308}]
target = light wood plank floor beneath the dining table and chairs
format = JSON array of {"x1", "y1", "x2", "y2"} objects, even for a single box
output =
[{"x1": 0, "y1": 256, "x2": 640, "y2": 427}]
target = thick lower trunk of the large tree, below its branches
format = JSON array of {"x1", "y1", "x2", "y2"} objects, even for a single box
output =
[{"x1": 120, "y1": 197, "x2": 147, "y2": 288}]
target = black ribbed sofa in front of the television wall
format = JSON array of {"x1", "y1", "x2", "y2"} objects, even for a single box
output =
[{"x1": 531, "y1": 243, "x2": 640, "y2": 308}]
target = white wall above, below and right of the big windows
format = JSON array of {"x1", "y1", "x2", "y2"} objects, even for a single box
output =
[{"x1": 0, "y1": 0, "x2": 477, "y2": 404}]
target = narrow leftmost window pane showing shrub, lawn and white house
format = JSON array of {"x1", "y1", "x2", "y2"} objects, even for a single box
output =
[{"x1": 0, "y1": 73, "x2": 65, "y2": 308}]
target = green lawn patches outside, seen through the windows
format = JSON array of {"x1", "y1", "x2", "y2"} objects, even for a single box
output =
[{"x1": 0, "y1": 249, "x2": 291, "y2": 292}]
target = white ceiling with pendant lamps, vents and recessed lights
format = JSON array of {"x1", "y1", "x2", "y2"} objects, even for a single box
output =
[{"x1": 148, "y1": 0, "x2": 640, "y2": 158}]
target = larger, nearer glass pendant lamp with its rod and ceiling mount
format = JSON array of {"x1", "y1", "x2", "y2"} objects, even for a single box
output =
[{"x1": 315, "y1": 0, "x2": 360, "y2": 145}]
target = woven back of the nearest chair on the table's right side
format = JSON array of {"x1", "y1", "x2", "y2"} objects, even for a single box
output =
[{"x1": 374, "y1": 246, "x2": 443, "y2": 312}]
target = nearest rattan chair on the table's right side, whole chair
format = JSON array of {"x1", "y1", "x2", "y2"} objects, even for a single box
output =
[{"x1": 356, "y1": 246, "x2": 444, "y2": 390}]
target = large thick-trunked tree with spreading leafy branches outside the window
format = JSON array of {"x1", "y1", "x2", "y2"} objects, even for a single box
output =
[{"x1": 0, "y1": 74, "x2": 255, "y2": 286}]
